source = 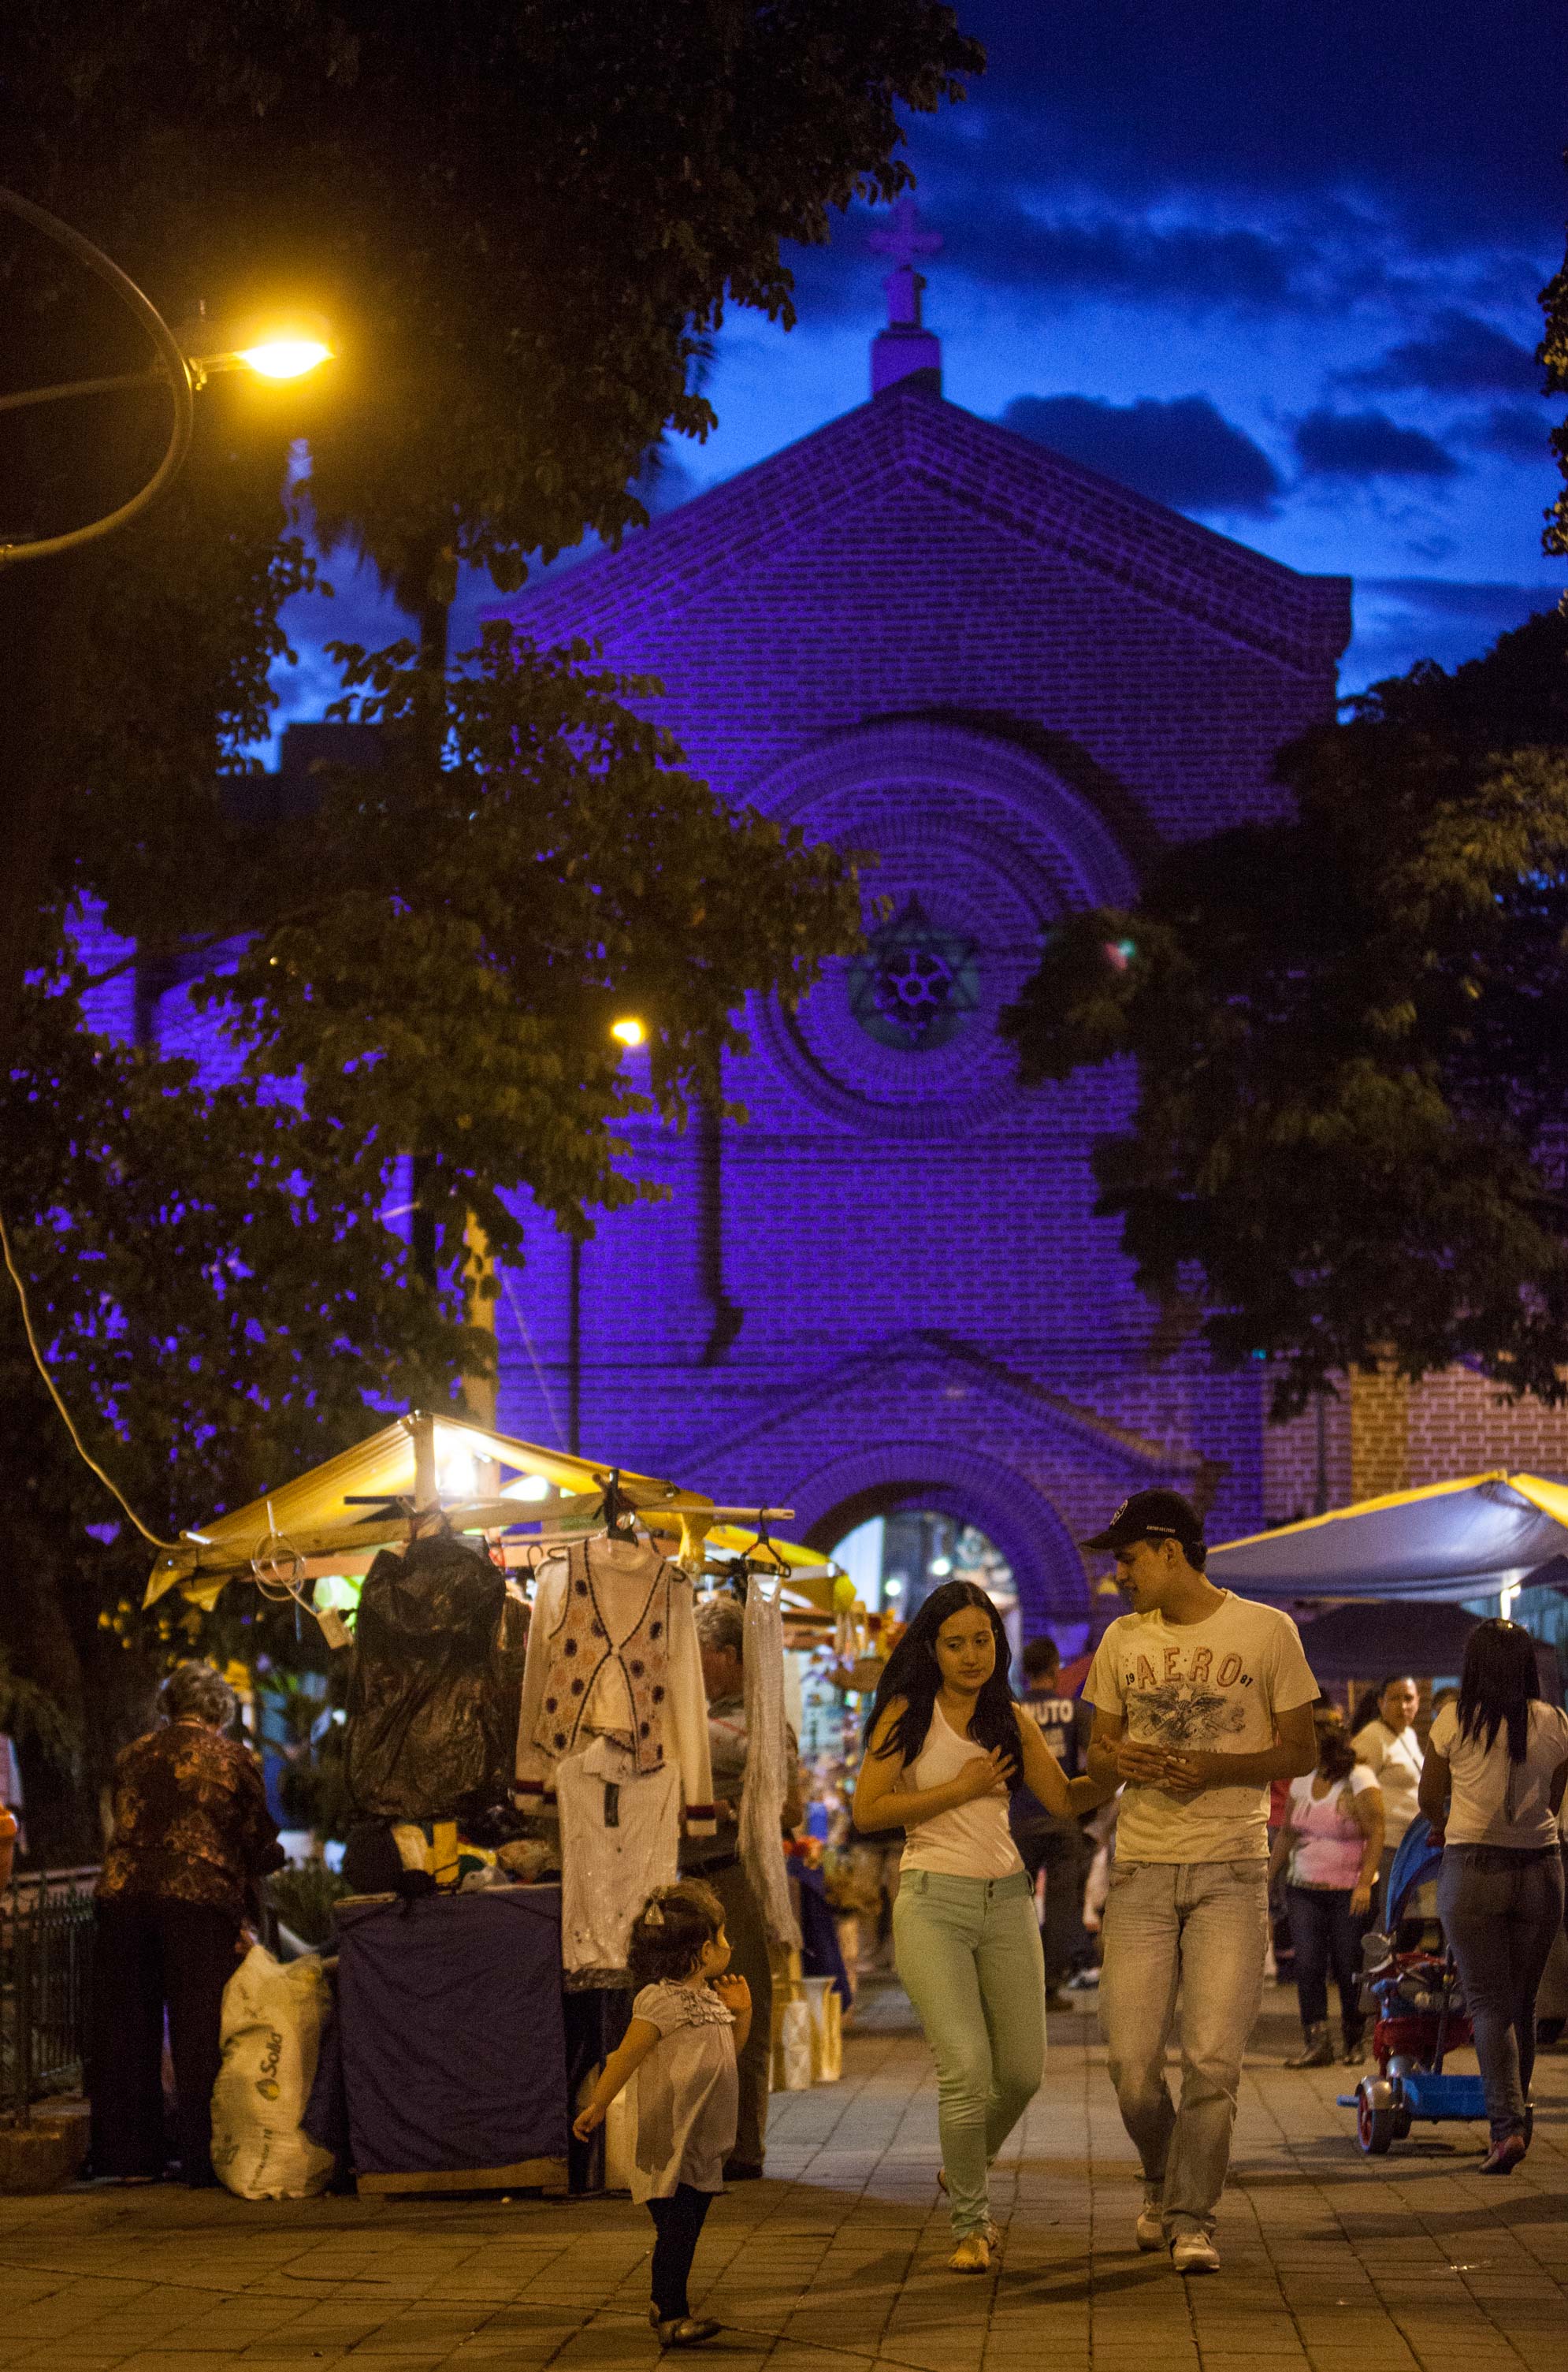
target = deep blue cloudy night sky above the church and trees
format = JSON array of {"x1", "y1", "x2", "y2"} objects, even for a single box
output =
[{"x1": 263, "y1": 0, "x2": 1568, "y2": 749}]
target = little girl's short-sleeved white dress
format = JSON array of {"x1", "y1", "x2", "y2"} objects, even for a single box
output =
[{"x1": 631, "y1": 1985, "x2": 740, "y2": 2206}]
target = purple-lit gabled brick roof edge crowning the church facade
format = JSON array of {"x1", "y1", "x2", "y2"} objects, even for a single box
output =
[{"x1": 489, "y1": 380, "x2": 1350, "y2": 671}]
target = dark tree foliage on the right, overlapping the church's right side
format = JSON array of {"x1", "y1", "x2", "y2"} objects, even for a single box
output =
[{"x1": 1005, "y1": 617, "x2": 1568, "y2": 1416}]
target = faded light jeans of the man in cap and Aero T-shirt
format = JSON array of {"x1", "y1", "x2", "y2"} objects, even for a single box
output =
[{"x1": 1098, "y1": 1855, "x2": 1269, "y2": 2239}]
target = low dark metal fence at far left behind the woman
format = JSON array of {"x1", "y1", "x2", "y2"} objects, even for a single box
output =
[{"x1": 0, "y1": 1869, "x2": 97, "y2": 2125}]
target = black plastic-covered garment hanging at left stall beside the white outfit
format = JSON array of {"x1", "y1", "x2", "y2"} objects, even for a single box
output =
[{"x1": 344, "y1": 1534, "x2": 517, "y2": 1822}]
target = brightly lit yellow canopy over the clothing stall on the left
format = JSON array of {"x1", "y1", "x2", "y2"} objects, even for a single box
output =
[{"x1": 143, "y1": 1411, "x2": 838, "y2": 1608}]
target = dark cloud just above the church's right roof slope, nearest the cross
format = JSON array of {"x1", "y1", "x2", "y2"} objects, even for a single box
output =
[{"x1": 1001, "y1": 396, "x2": 1281, "y2": 512}]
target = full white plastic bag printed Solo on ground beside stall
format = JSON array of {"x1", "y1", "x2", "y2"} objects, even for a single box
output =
[{"x1": 214, "y1": 1945, "x2": 334, "y2": 2199}]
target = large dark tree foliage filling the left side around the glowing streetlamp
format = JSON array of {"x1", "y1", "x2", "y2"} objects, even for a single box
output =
[{"x1": 0, "y1": 0, "x2": 979, "y2": 1850}]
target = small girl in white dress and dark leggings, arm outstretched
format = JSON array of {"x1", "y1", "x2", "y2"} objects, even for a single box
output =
[{"x1": 572, "y1": 1879, "x2": 752, "y2": 2348}]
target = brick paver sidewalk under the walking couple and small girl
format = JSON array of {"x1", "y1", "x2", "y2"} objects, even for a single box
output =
[{"x1": 0, "y1": 1992, "x2": 1568, "y2": 2372}]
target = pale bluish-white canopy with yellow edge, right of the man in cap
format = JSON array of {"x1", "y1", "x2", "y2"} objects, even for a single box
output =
[{"x1": 1207, "y1": 1470, "x2": 1568, "y2": 1601}]
